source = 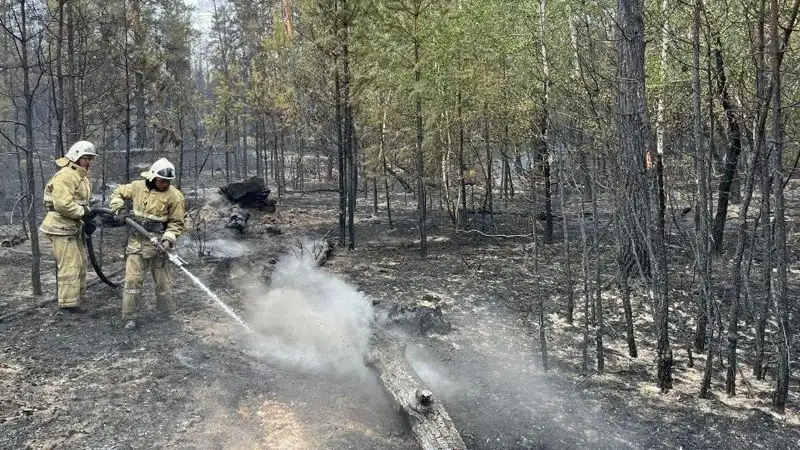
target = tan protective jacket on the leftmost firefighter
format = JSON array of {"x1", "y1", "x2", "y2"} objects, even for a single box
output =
[{"x1": 39, "y1": 158, "x2": 92, "y2": 236}]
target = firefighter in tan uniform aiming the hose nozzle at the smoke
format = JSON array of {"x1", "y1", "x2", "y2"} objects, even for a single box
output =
[{"x1": 110, "y1": 158, "x2": 185, "y2": 330}]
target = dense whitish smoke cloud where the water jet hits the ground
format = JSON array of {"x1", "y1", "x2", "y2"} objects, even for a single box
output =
[{"x1": 248, "y1": 243, "x2": 373, "y2": 375}]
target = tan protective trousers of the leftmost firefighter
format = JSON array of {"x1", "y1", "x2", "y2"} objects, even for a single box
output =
[{"x1": 45, "y1": 234, "x2": 86, "y2": 308}]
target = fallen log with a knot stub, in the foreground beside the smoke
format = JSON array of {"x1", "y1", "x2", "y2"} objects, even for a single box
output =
[{"x1": 366, "y1": 339, "x2": 466, "y2": 450}]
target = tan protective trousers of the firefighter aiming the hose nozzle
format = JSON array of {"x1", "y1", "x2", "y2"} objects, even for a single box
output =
[{"x1": 122, "y1": 251, "x2": 173, "y2": 319}]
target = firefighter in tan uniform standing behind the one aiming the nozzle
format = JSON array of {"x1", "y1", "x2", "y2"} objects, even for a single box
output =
[{"x1": 39, "y1": 141, "x2": 97, "y2": 312}]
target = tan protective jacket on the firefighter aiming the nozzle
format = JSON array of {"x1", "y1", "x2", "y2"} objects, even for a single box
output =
[{"x1": 109, "y1": 180, "x2": 185, "y2": 245}]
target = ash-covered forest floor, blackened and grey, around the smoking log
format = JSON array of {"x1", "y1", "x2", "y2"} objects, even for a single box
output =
[{"x1": 0, "y1": 188, "x2": 800, "y2": 449}]
